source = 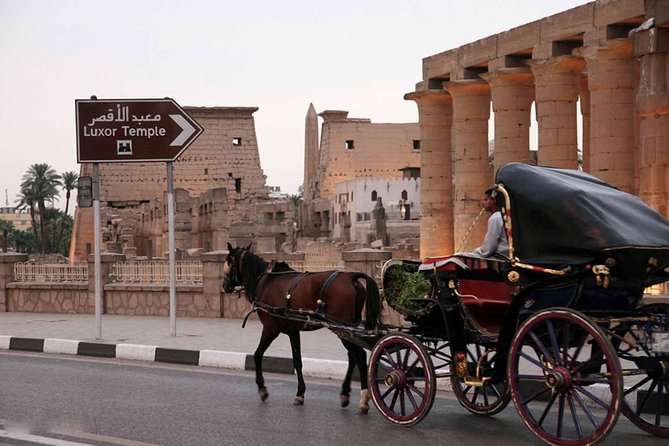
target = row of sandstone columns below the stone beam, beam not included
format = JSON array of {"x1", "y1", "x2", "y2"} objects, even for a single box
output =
[{"x1": 407, "y1": 39, "x2": 669, "y2": 257}]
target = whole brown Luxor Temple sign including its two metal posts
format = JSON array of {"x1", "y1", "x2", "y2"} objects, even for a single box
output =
[{"x1": 75, "y1": 98, "x2": 204, "y2": 338}]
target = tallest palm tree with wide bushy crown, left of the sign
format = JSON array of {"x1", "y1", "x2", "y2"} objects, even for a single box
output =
[{"x1": 21, "y1": 163, "x2": 62, "y2": 254}]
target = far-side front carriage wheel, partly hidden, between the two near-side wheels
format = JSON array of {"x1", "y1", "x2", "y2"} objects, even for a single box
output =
[{"x1": 451, "y1": 343, "x2": 511, "y2": 415}]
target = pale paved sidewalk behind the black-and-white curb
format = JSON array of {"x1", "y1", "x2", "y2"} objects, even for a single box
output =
[{"x1": 0, "y1": 312, "x2": 347, "y2": 361}]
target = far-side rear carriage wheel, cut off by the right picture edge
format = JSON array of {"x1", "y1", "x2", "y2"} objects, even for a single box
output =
[{"x1": 610, "y1": 304, "x2": 669, "y2": 438}]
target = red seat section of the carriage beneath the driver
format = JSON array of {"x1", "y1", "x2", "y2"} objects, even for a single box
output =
[{"x1": 419, "y1": 254, "x2": 515, "y2": 334}]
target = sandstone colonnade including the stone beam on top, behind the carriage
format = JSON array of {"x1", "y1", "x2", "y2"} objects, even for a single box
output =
[{"x1": 405, "y1": 0, "x2": 669, "y2": 257}]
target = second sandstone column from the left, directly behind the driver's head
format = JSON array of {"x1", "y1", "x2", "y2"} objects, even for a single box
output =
[{"x1": 445, "y1": 80, "x2": 493, "y2": 251}]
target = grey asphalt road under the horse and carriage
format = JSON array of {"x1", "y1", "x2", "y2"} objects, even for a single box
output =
[{"x1": 0, "y1": 352, "x2": 663, "y2": 446}]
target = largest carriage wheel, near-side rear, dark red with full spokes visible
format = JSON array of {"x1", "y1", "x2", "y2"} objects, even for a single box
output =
[{"x1": 507, "y1": 308, "x2": 623, "y2": 445}]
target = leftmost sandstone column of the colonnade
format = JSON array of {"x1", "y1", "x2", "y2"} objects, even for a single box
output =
[{"x1": 404, "y1": 91, "x2": 453, "y2": 258}]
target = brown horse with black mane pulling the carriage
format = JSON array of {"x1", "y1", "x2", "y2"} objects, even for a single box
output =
[{"x1": 224, "y1": 243, "x2": 381, "y2": 413}]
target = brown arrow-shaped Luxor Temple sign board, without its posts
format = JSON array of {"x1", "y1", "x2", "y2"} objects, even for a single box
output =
[{"x1": 75, "y1": 98, "x2": 203, "y2": 163}]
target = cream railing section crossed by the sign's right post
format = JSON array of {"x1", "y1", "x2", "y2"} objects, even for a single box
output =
[{"x1": 109, "y1": 260, "x2": 202, "y2": 285}]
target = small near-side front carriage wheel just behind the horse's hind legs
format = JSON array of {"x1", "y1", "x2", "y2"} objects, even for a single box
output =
[{"x1": 368, "y1": 334, "x2": 436, "y2": 426}]
